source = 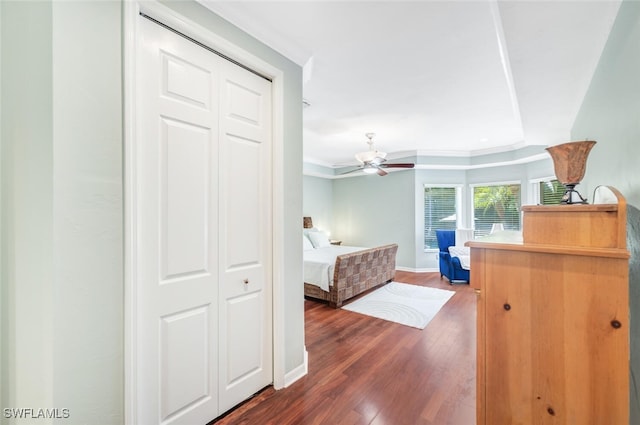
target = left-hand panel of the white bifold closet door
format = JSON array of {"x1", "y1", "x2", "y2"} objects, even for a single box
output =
[{"x1": 135, "y1": 18, "x2": 219, "y2": 424}]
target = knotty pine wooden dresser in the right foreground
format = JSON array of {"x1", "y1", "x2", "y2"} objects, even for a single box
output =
[{"x1": 467, "y1": 189, "x2": 629, "y2": 425}]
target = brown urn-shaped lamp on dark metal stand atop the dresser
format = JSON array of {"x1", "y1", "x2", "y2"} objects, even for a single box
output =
[{"x1": 547, "y1": 140, "x2": 596, "y2": 204}]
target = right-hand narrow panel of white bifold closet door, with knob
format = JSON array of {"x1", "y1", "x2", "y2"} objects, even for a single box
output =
[{"x1": 219, "y1": 58, "x2": 273, "y2": 410}]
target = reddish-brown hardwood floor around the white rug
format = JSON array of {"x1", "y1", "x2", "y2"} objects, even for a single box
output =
[{"x1": 214, "y1": 272, "x2": 476, "y2": 425}]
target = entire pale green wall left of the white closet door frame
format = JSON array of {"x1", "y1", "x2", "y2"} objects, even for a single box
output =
[{"x1": 0, "y1": 1, "x2": 124, "y2": 424}]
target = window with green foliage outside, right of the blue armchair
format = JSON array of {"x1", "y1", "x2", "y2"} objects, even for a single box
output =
[{"x1": 473, "y1": 184, "x2": 521, "y2": 237}]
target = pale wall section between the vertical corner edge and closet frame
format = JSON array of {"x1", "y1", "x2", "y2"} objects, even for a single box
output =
[{"x1": 51, "y1": 1, "x2": 124, "y2": 424}]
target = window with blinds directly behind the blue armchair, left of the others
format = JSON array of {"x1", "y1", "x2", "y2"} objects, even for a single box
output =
[{"x1": 424, "y1": 186, "x2": 460, "y2": 249}]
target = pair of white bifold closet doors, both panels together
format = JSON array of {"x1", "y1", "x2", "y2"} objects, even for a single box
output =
[{"x1": 133, "y1": 17, "x2": 272, "y2": 424}]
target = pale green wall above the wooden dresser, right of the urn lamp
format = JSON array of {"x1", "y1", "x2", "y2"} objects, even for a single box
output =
[{"x1": 571, "y1": 1, "x2": 640, "y2": 208}]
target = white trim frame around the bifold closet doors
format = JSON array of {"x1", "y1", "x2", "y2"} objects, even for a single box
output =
[{"x1": 123, "y1": 0, "x2": 285, "y2": 425}]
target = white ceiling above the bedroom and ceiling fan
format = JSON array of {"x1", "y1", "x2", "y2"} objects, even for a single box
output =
[{"x1": 200, "y1": 0, "x2": 620, "y2": 166}]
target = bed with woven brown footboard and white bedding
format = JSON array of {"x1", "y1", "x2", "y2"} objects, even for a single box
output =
[{"x1": 303, "y1": 229, "x2": 398, "y2": 308}]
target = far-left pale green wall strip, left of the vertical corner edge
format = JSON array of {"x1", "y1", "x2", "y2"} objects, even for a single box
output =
[{"x1": 0, "y1": 2, "x2": 56, "y2": 412}]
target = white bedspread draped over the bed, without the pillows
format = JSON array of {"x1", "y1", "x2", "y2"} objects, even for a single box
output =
[{"x1": 303, "y1": 245, "x2": 369, "y2": 292}]
